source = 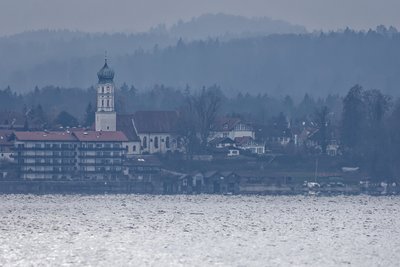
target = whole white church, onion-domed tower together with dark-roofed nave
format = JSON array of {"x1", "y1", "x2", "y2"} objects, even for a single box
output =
[{"x1": 95, "y1": 57, "x2": 182, "y2": 157}]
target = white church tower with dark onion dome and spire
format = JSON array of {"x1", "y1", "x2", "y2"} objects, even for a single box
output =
[{"x1": 95, "y1": 59, "x2": 117, "y2": 131}]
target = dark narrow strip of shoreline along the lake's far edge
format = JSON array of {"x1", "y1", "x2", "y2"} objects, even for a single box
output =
[{"x1": 0, "y1": 180, "x2": 394, "y2": 196}]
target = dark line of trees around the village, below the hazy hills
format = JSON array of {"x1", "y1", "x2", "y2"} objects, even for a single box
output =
[{"x1": 0, "y1": 84, "x2": 400, "y2": 180}]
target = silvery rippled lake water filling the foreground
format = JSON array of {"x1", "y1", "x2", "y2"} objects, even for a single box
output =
[{"x1": 0, "y1": 195, "x2": 400, "y2": 266}]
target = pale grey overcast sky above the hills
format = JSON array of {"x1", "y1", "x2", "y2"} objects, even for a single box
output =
[{"x1": 0, "y1": 0, "x2": 400, "y2": 36}]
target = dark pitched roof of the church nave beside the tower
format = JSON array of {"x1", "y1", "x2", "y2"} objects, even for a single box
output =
[{"x1": 133, "y1": 111, "x2": 178, "y2": 133}]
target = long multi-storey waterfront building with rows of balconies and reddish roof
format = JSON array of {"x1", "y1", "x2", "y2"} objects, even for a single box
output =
[{"x1": 14, "y1": 131, "x2": 128, "y2": 180}]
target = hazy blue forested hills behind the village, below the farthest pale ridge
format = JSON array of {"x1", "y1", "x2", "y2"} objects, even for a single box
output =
[{"x1": 0, "y1": 27, "x2": 400, "y2": 97}]
